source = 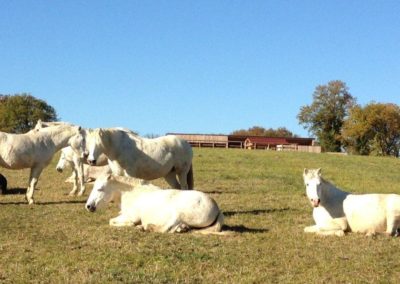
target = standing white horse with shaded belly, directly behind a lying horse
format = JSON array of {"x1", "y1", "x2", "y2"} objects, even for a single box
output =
[{"x1": 82, "y1": 128, "x2": 193, "y2": 189}]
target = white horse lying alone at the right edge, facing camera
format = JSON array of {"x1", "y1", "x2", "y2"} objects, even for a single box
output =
[{"x1": 303, "y1": 169, "x2": 400, "y2": 236}]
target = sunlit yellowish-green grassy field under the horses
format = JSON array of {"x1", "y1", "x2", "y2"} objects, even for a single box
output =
[{"x1": 0, "y1": 149, "x2": 400, "y2": 283}]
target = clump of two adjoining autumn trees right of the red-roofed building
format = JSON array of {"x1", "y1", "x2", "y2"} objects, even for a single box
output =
[{"x1": 297, "y1": 80, "x2": 400, "y2": 157}]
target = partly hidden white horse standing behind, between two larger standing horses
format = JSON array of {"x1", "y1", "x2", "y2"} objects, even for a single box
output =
[{"x1": 56, "y1": 147, "x2": 110, "y2": 196}]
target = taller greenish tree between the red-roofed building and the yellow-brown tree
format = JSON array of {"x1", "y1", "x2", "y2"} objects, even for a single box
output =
[{"x1": 297, "y1": 80, "x2": 356, "y2": 152}]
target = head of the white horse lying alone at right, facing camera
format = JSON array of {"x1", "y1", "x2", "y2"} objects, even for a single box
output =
[{"x1": 303, "y1": 169, "x2": 322, "y2": 207}]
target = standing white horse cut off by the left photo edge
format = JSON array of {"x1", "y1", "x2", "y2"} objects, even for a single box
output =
[{"x1": 0, "y1": 125, "x2": 84, "y2": 204}]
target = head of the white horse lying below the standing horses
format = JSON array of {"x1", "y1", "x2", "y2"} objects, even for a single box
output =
[{"x1": 85, "y1": 174, "x2": 114, "y2": 212}]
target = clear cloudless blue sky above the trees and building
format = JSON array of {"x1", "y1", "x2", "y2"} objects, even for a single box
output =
[{"x1": 0, "y1": 0, "x2": 400, "y2": 136}]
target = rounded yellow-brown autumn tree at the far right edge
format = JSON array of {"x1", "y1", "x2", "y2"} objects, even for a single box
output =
[{"x1": 342, "y1": 102, "x2": 400, "y2": 157}]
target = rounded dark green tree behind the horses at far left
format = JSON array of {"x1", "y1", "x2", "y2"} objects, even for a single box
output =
[{"x1": 0, "y1": 93, "x2": 58, "y2": 133}]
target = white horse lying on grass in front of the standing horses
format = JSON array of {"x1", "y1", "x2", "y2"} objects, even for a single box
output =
[{"x1": 86, "y1": 175, "x2": 224, "y2": 234}]
